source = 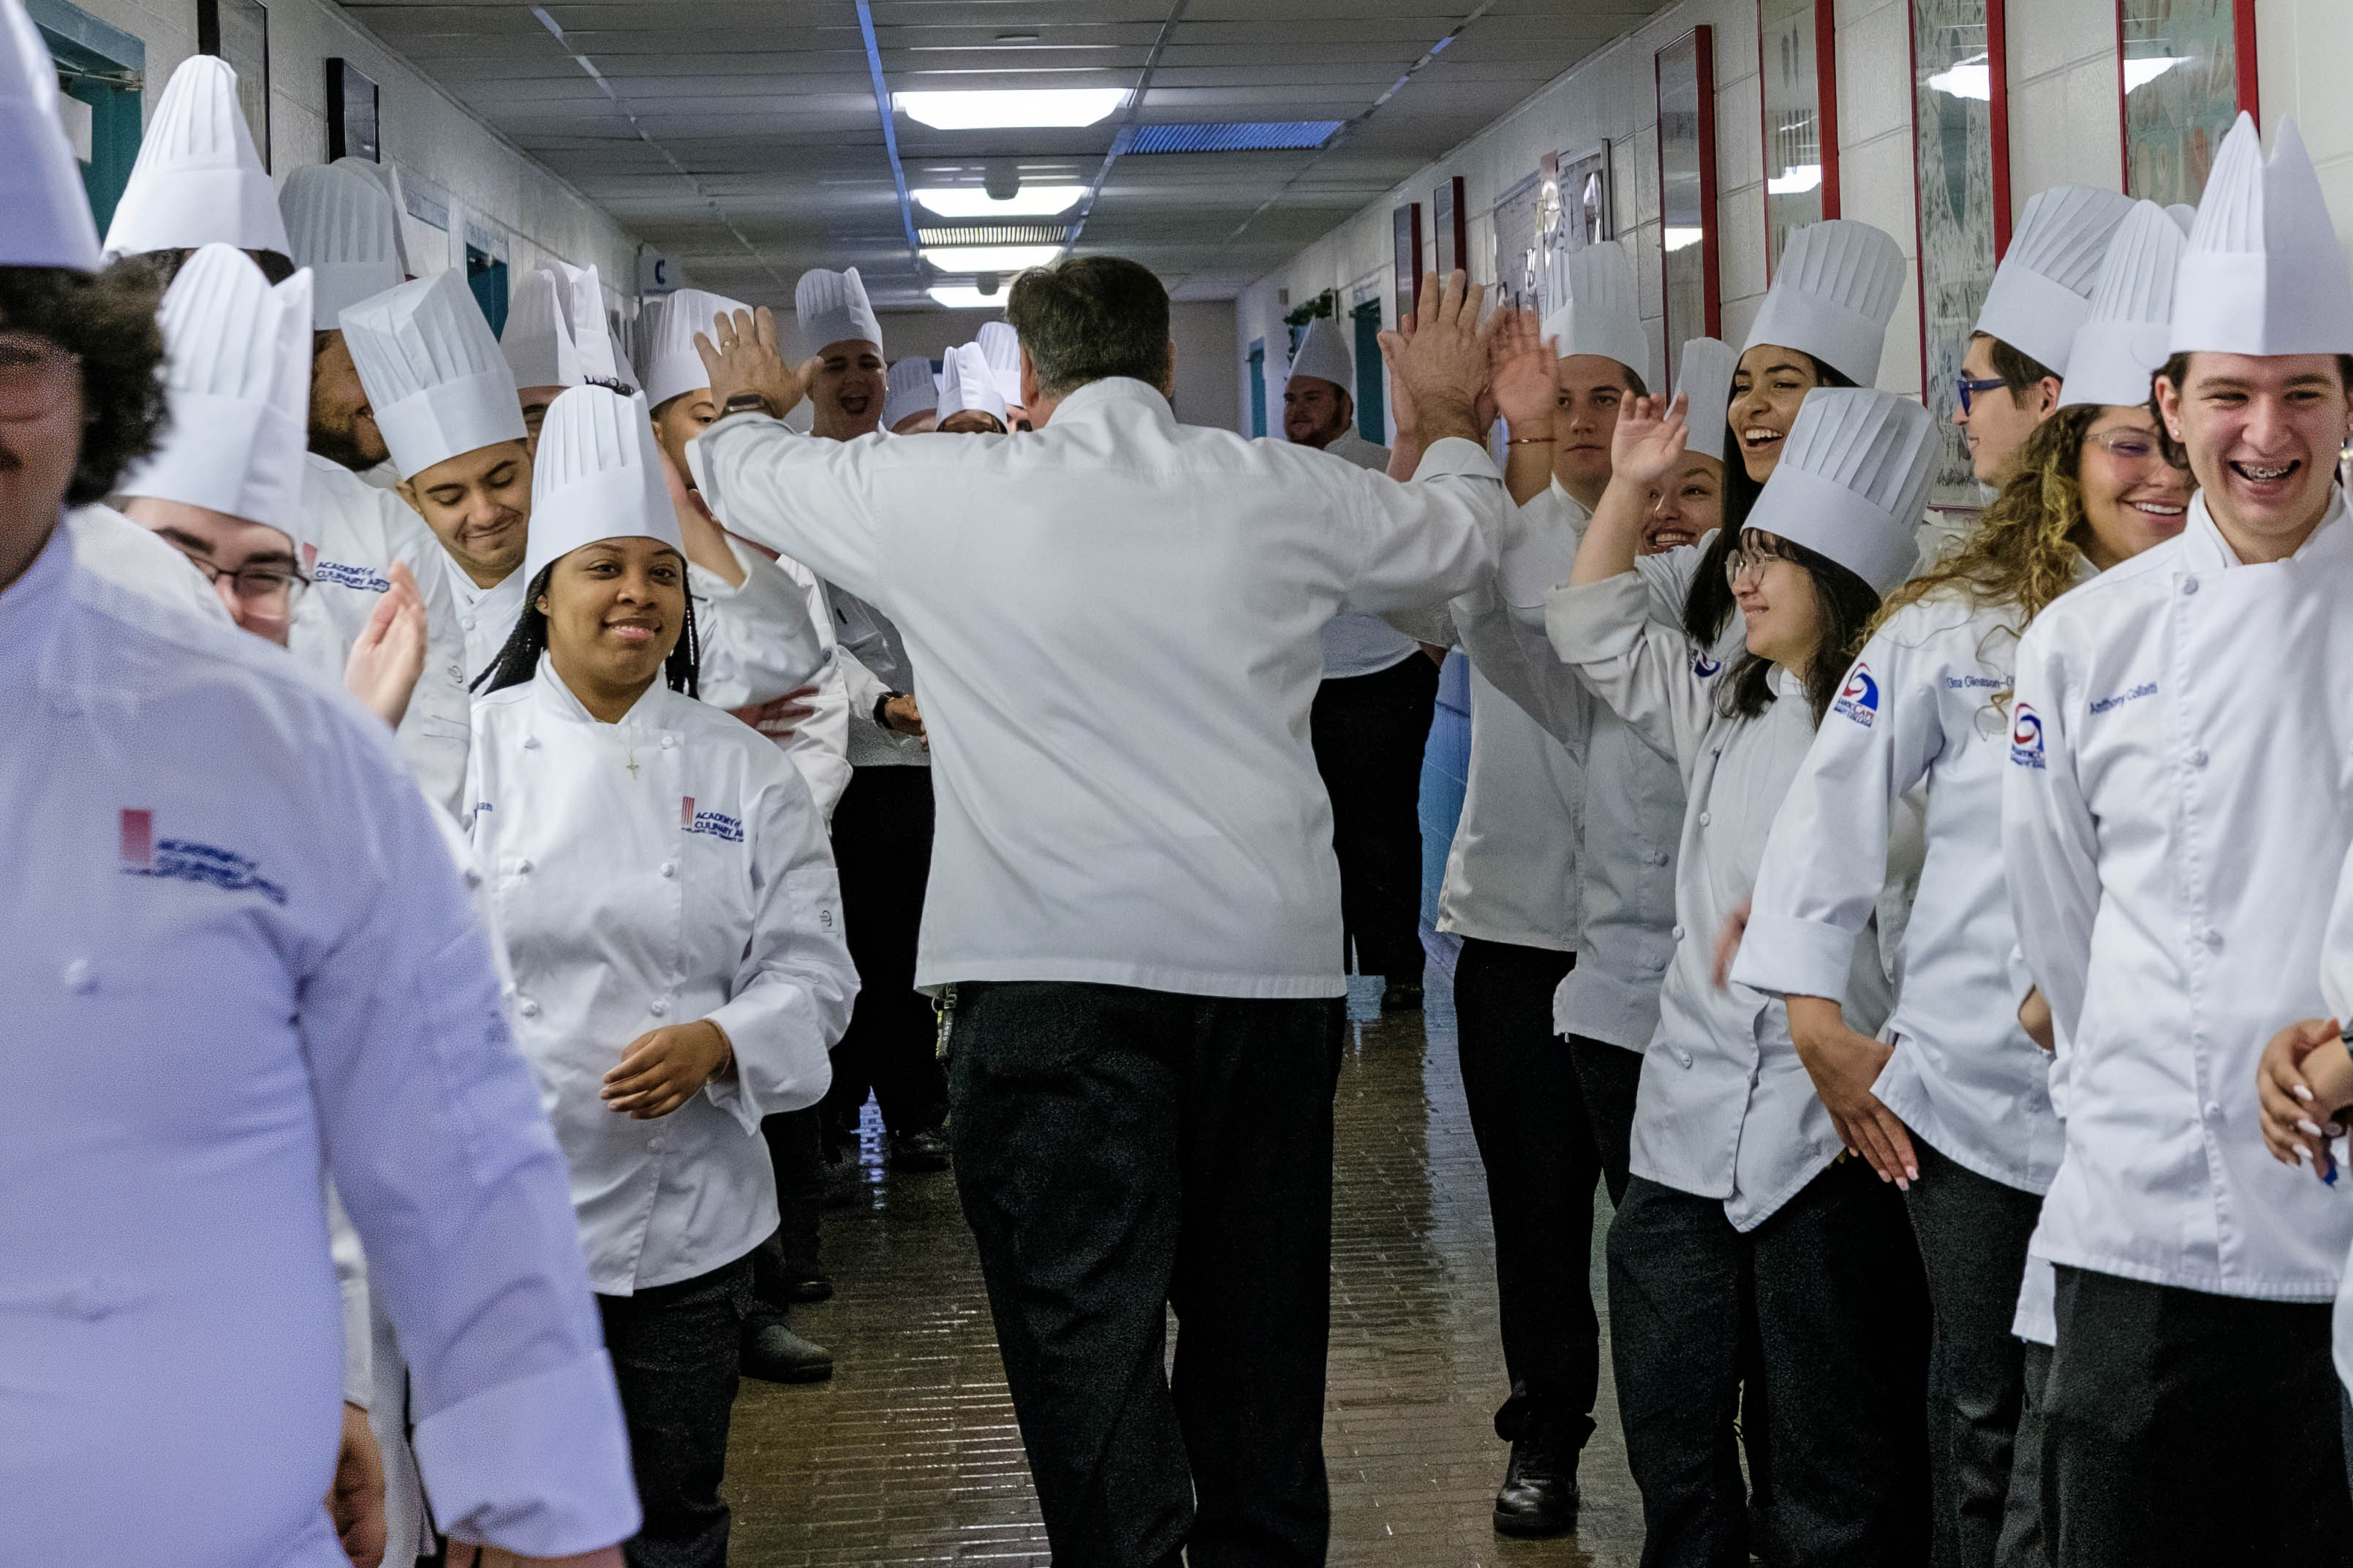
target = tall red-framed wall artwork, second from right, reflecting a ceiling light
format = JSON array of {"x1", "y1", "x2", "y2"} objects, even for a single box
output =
[{"x1": 1911, "y1": 0, "x2": 2009, "y2": 510}]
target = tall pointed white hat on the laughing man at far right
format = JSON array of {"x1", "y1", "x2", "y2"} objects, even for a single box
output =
[{"x1": 2172, "y1": 113, "x2": 2353, "y2": 355}]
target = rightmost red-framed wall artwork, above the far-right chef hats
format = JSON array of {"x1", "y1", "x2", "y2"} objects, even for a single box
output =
[{"x1": 2115, "y1": 0, "x2": 2261, "y2": 207}]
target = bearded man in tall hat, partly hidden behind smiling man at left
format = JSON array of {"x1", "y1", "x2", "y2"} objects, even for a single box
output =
[{"x1": 278, "y1": 164, "x2": 471, "y2": 814}]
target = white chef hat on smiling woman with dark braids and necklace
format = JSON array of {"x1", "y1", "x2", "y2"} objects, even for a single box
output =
[{"x1": 522, "y1": 385, "x2": 687, "y2": 583}]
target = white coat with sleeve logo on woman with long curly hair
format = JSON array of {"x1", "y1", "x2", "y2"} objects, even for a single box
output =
[{"x1": 1731, "y1": 588, "x2": 2061, "y2": 1192}]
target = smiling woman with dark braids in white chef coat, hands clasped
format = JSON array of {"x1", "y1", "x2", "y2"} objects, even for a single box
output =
[{"x1": 468, "y1": 385, "x2": 856, "y2": 1564}]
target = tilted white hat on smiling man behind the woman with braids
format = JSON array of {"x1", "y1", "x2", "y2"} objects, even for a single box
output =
[{"x1": 341, "y1": 270, "x2": 525, "y2": 480}]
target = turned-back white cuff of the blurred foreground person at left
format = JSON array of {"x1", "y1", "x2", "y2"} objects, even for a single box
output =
[{"x1": 414, "y1": 1349, "x2": 640, "y2": 1556}]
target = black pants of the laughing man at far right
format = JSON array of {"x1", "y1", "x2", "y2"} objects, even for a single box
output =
[{"x1": 2042, "y1": 1265, "x2": 2353, "y2": 1568}]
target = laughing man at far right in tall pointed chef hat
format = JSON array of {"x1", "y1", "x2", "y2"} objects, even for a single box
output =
[{"x1": 2003, "y1": 115, "x2": 2353, "y2": 1568}]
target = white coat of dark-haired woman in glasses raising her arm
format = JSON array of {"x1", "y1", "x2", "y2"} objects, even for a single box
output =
[{"x1": 1546, "y1": 571, "x2": 1887, "y2": 1232}]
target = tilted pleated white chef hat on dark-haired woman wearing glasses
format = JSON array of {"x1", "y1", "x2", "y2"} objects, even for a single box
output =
[{"x1": 1746, "y1": 385, "x2": 1939, "y2": 595}]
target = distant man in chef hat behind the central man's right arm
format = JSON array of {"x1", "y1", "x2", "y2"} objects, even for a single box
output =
[{"x1": 1283, "y1": 317, "x2": 1438, "y2": 1013}]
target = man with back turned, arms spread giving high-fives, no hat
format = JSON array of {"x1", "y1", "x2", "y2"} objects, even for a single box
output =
[{"x1": 692, "y1": 257, "x2": 1503, "y2": 1568}]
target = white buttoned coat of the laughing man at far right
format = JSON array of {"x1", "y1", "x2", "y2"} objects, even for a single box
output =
[{"x1": 2003, "y1": 496, "x2": 2353, "y2": 1300}]
